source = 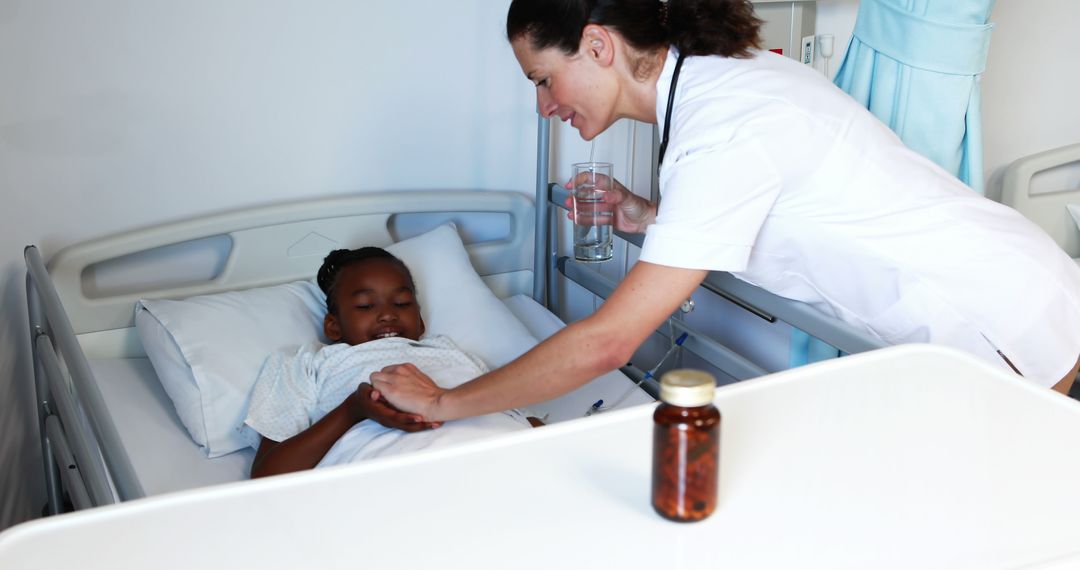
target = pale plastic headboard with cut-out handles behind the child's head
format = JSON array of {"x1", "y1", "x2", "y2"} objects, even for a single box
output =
[{"x1": 49, "y1": 190, "x2": 535, "y2": 352}]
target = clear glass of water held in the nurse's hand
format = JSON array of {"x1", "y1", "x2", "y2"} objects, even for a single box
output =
[{"x1": 573, "y1": 162, "x2": 615, "y2": 262}]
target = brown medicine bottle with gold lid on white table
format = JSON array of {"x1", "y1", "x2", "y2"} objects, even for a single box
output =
[{"x1": 652, "y1": 369, "x2": 720, "y2": 523}]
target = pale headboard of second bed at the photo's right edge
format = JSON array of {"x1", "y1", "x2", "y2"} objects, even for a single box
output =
[{"x1": 1001, "y1": 145, "x2": 1080, "y2": 257}]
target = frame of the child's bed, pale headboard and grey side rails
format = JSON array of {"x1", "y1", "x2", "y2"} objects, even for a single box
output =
[{"x1": 24, "y1": 112, "x2": 885, "y2": 514}]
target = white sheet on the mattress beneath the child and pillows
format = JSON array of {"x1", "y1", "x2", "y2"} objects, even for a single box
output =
[{"x1": 90, "y1": 295, "x2": 652, "y2": 496}]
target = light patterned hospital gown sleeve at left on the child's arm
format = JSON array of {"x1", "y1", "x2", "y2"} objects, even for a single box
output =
[{"x1": 244, "y1": 343, "x2": 322, "y2": 447}]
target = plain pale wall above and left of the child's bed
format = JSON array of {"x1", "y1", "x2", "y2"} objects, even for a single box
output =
[{"x1": 0, "y1": 0, "x2": 536, "y2": 528}]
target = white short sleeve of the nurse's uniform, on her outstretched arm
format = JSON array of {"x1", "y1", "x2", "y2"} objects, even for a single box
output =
[{"x1": 640, "y1": 140, "x2": 781, "y2": 272}]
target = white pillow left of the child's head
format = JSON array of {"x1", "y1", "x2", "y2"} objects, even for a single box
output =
[{"x1": 135, "y1": 281, "x2": 326, "y2": 458}]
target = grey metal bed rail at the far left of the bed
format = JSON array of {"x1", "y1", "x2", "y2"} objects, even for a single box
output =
[{"x1": 23, "y1": 245, "x2": 145, "y2": 514}]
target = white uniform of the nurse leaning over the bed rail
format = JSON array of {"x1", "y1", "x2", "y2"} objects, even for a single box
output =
[{"x1": 640, "y1": 50, "x2": 1080, "y2": 386}]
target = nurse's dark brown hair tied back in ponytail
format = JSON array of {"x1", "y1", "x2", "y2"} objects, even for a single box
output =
[{"x1": 507, "y1": 0, "x2": 761, "y2": 57}]
